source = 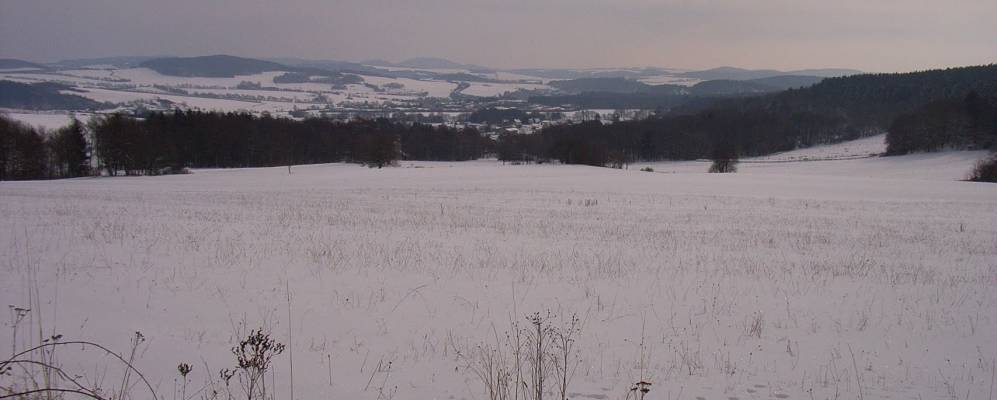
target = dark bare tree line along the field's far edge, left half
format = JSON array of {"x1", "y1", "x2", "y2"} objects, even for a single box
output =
[{"x1": 0, "y1": 110, "x2": 494, "y2": 180}]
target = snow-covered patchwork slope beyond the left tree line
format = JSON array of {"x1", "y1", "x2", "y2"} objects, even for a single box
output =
[{"x1": 0, "y1": 62, "x2": 560, "y2": 115}]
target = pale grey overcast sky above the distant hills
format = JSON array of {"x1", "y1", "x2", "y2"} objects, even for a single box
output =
[{"x1": 0, "y1": 0, "x2": 997, "y2": 71}]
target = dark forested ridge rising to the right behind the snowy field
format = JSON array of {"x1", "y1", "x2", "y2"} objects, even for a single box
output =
[{"x1": 506, "y1": 65, "x2": 997, "y2": 165}]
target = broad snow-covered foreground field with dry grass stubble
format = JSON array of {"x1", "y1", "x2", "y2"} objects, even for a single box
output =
[{"x1": 0, "y1": 139, "x2": 997, "y2": 399}]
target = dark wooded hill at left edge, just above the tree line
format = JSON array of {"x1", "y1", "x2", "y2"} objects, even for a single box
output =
[{"x1": 0, "y1": 81, "x2": 109, "y2": 110}]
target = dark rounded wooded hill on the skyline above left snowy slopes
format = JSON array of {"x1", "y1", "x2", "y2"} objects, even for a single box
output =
[{"x1": 139, "y1": 55, "x2": 291, "y2": 78}]
